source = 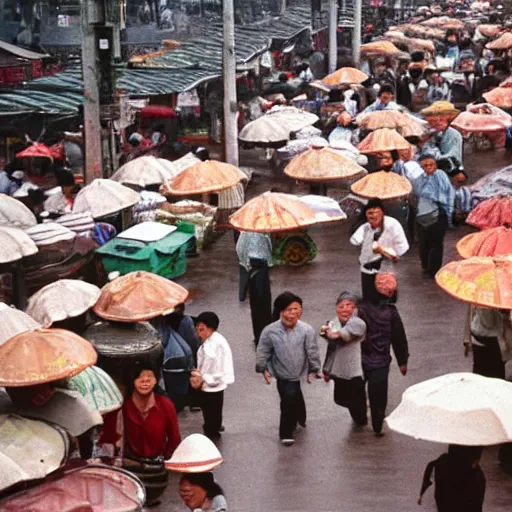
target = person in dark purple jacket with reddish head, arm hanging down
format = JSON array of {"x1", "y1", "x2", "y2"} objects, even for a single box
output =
[{"x1": 359, "y1": 273, "x2": 409, "y2": 437}]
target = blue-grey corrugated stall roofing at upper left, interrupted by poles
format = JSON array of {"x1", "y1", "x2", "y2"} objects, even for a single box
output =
[{"x1": 6, "y1": 6, "x2": 322, "y2": 113}]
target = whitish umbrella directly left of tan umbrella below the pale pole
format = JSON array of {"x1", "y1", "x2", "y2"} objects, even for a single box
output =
[{"x1": 110, "y1": 156, "x2": 179, "y2": 188}]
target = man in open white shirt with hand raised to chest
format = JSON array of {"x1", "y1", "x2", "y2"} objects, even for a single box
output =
[{"x1": 350, "y1": 199, "x2": 409, "y2": 301}]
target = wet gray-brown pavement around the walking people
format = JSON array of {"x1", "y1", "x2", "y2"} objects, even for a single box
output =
[{"x1": 151, "y1": 148, "x2": 512, "y2": 512}]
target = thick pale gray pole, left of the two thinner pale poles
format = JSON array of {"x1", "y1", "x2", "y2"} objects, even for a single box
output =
[{"x1": 222, "y1": 0, "x2": 238, "y2": 167}]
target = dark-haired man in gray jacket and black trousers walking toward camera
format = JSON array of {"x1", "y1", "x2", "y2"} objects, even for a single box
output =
[{"x1": 256, "y1": 292, "x2": 321, "y2": 446}]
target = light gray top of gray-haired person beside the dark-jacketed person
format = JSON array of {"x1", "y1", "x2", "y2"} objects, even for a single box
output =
[{"x1": 323, "y1": 311, "x2": 366, "y2": 379}]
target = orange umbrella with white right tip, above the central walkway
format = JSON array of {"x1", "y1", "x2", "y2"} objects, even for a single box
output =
[{"x1": 229, "y1": 192, "x2": 345, "y2": 233}]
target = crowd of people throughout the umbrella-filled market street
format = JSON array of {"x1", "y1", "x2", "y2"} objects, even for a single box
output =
[{"x1": 0, "y1": 0, "x2": 512, "y2": 512}]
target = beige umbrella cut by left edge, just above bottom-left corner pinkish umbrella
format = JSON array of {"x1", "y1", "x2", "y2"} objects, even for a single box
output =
[{"x1": 0, "y1": 414, "x2": 69, "y2": 492}]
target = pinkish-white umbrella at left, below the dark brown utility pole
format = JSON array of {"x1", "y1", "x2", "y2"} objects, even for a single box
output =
[{"x1": 73, "y1": 179, "x2": 140, "y2": 219}]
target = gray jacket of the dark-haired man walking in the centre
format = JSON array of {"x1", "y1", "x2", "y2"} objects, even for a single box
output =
[{"x1": 256, "y1": 320, "x2": 321, "y2": 381}]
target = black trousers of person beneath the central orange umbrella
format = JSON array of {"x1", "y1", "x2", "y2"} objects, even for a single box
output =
[{"x1": 249, "y1": 260, "x2": 272, "y2": 346}]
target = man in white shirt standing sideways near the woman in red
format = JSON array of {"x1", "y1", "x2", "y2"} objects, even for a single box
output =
[{"x1": 192, "y1": 311, "x2": 235, "y2": 439}]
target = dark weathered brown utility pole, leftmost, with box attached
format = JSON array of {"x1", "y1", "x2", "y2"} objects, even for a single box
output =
[{"x1": 81, "y1": 0, "x2": 104, "y2": 184}]
